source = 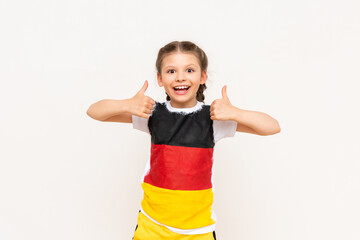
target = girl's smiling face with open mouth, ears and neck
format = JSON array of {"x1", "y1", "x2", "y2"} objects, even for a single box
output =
[{"x1": 157, "y1": 52, "x2": 207, "y2": 108}]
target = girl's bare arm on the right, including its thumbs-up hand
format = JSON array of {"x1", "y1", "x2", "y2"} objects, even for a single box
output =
[{"x1": 210, "y1": 86, "x2": 281, "y2": 136}]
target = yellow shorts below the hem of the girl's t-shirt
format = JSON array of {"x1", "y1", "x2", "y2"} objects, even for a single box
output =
[{"x1": 133, "y1": 212, "x2": 216, "y2": 240}]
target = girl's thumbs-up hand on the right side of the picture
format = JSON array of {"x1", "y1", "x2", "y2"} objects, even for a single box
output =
[{"x1": 210, "y1": 85, "x2": 236, "y2": 121}]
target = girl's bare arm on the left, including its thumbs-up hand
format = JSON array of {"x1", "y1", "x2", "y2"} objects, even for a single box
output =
[{"x1": 86, "y1": 81, "x2": 155, "y2": 123}]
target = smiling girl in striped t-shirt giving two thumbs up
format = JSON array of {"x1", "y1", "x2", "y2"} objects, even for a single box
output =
[{"x1": 87, "y1": 41, "x2": 280, "y2": 240}]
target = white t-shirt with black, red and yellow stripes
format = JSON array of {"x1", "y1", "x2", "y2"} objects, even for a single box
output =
[{"x1": 132, "y1": 101, "x2": 237, "y2": 234}]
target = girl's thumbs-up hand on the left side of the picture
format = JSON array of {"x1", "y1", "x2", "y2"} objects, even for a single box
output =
[{"x1": 129, "y1": 80, "x2": 155, "y2": 119}]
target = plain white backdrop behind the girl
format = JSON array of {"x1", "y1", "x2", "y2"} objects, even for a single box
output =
[{"x1": 0, "y1": 0, "x2": 360, "y2": 240}]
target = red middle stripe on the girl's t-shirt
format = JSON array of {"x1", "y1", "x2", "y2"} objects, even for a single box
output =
[{"x1": 144, "y1": 143, "x2": 214, "y2": 190}]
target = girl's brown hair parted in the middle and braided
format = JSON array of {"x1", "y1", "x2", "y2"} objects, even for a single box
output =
[{"x1": 155, "y1": 41, "x2": 208, "y2": 102}]
